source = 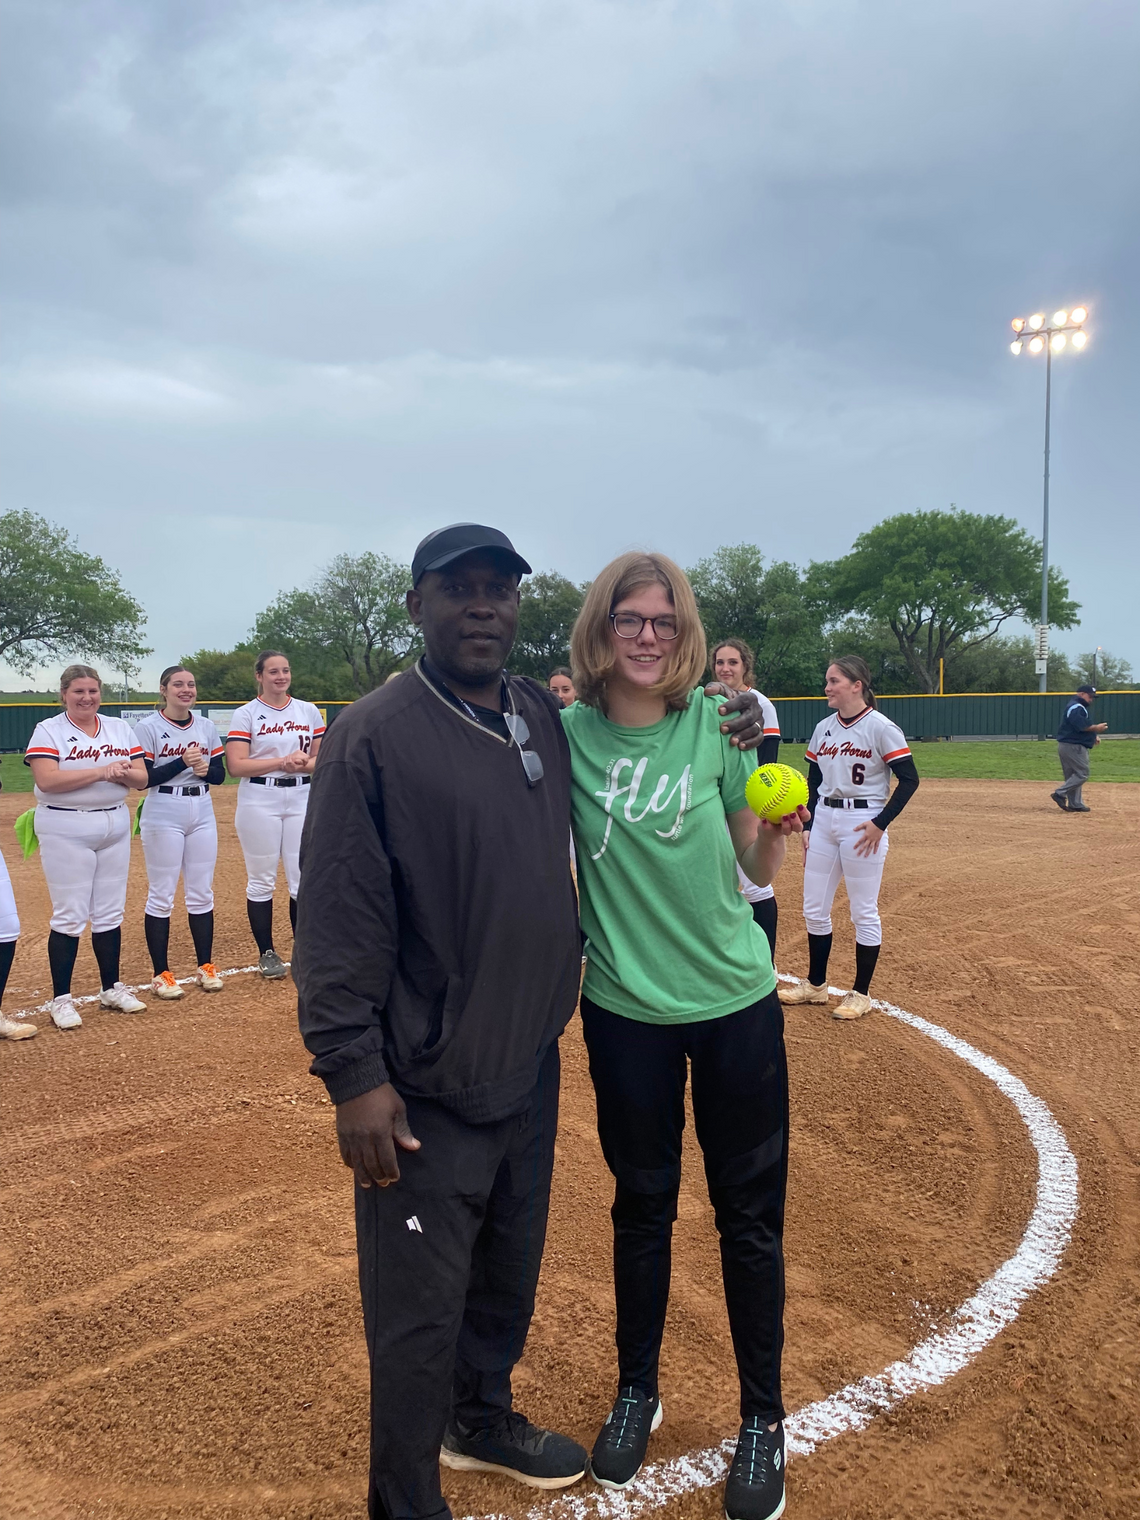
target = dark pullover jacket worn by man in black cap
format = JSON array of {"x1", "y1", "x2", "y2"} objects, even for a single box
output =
[{"x1": 293, "y1": 667, "x2": 581, "y2": 1123}]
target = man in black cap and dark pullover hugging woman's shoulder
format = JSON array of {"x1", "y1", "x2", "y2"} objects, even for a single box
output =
[{"x1": 293, "y1": 523, "x2": 772, "y2": 1520}]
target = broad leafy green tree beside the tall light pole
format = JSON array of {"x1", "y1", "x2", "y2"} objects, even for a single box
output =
[{"x1": 809, "y1": 511, "x2": 1079, "y2": 692}]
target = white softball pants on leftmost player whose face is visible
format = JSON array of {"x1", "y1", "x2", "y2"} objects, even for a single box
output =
[{"x1": 35, "y1": 803, "x2": 131, "y2": 938}]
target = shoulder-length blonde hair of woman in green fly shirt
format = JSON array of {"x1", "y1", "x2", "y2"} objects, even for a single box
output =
[{"x1": 570, "y1": 550, "x2": 708, "y2": 713}]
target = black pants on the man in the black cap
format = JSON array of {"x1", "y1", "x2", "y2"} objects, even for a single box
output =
[{"x1": 356, "y1": 1044, "x2": 559, "y2": 1520}]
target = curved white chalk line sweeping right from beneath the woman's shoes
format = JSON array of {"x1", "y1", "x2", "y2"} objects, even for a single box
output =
[{"x1": 467, "y1": 976, "x2": 1078, "y2": 1520}]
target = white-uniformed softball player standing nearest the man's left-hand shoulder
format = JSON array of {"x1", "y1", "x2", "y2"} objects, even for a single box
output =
[{"x1": 225, "y1": 649, "x2": 325, "y2": 980}]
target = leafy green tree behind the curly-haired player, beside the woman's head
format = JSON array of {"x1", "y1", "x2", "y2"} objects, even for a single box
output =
[{"x1": 689, "y1": 544, "x2": 827, "y2": 696}]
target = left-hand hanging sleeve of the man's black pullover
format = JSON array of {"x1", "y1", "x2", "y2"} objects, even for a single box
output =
[{"x1": 293, "y1": 729, "x2": 397, "y2": 1104}]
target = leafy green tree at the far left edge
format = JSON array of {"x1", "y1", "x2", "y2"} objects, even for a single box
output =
[{"x1": 0, "y1": 512, "x2": 150, "y2": 673}]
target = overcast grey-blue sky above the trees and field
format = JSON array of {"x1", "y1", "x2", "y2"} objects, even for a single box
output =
[{"x1": 0, "y1": 0, "x2": 1140, "y2": 689}]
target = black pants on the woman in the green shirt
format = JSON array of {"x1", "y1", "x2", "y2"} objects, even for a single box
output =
[{"x1": 582, "y1": 993, "x2": 787, "y2": 1421}]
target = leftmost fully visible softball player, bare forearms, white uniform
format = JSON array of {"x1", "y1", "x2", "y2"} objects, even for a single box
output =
[{"x1": 24, "y1": 666, "x2": 146, "y2": 1029}]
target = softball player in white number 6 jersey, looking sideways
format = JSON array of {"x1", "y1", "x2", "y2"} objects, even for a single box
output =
[{"x1": 780, "y1": 657, "x2": 918, "y2": 1018}]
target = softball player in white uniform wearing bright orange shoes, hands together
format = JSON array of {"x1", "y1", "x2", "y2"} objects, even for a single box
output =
[{"x1": 135, "y1": 666, "x2": 225, "y2": 999}]
